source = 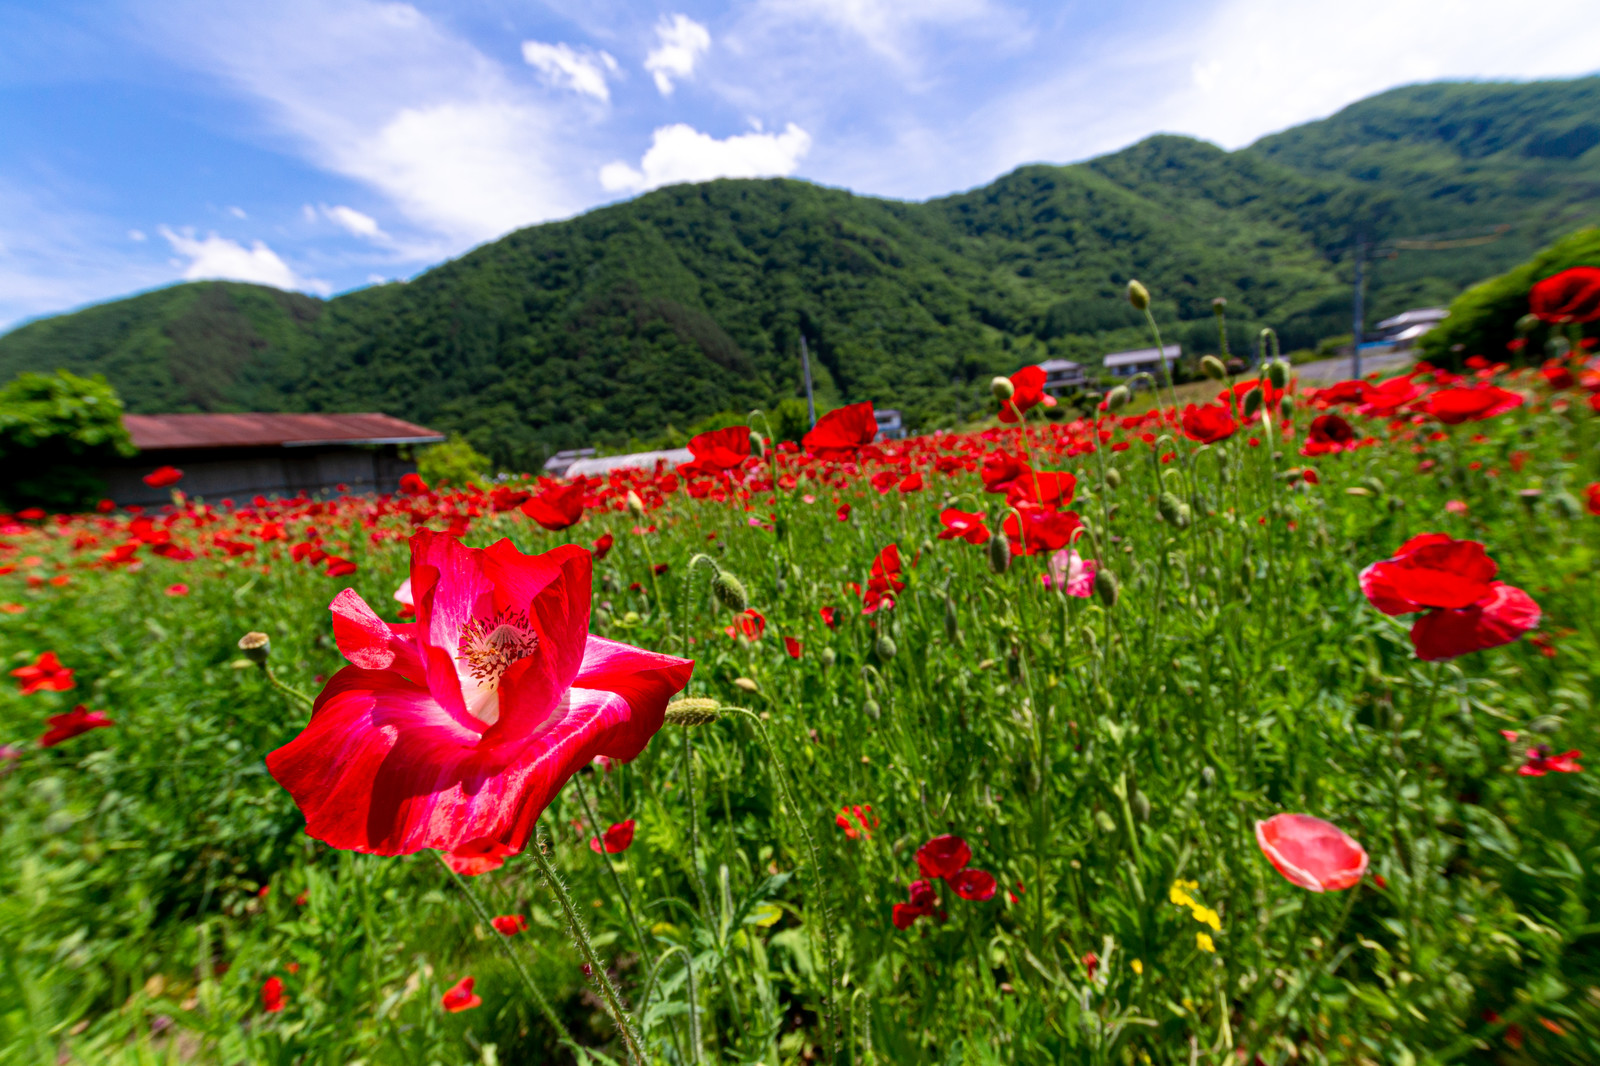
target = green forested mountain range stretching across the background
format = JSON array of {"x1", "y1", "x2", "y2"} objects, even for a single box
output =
[{"x1": 0, "y1": 78, "x2": 1600, "y2": 466}]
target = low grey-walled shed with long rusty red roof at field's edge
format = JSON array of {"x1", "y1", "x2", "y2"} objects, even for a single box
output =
[{"x1": 106, "y1": 415, "x2": 445, "y2": 506}]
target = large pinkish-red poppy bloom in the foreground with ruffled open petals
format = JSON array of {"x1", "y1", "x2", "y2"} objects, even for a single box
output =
[{"x1": 267, "y1": 530, "x2": 694, "y2": 855}]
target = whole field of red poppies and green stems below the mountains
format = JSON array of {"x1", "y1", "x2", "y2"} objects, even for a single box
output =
[{"x1": 0, "y1": 278, "x2": 1600, "y2": 1066}]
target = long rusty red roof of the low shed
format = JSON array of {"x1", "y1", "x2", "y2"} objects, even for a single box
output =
[{"x1": 122, "y1": 413, "x2": 445, "y2": 451}]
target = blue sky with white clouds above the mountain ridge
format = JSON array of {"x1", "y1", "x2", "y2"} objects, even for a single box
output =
[{"x1": 0, "y1": 0, "x2": 1600, "y2": 328}]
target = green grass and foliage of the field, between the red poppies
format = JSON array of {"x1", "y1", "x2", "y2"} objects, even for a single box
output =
[{"x1": 0, "y1": 369, "x2": 1600, "y2": 1066}]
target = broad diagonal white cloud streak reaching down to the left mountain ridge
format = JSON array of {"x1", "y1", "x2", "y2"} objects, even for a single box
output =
[{"x1": 141, "y1": 0, "x2": 587, "y2": 244}]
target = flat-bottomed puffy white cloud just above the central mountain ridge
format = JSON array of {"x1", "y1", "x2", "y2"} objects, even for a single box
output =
[{"x1": 600, "y1": 122, "x2": 811, "y2": 192}]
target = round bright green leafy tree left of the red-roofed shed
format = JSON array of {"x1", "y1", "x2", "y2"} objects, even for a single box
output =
[{"x1": 0, "y1": 370, "x2": 136, "y2": 511}]
